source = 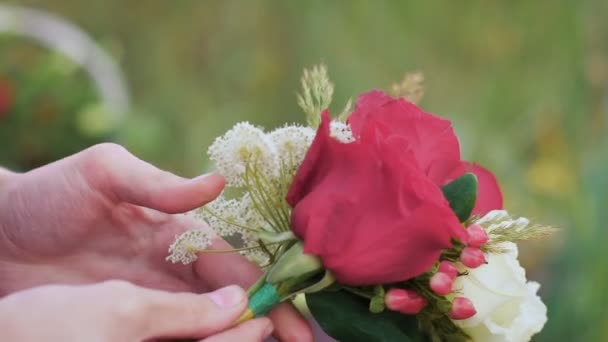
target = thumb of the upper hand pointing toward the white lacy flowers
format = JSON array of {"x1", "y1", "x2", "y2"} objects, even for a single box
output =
[{"x1": 74, "y1": 144, "x2": 224, "y2": 213}]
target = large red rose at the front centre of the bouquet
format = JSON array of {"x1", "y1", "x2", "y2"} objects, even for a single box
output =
[{"x1": 287, "y1": 108, "x2": 466, "y2": 286}]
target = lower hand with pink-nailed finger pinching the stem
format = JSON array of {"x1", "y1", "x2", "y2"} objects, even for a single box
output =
[{"x1": 0, "y1": 281, "x2": 272, "y2": 342}]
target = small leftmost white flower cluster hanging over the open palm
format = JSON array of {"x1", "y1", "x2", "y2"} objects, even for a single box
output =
[{"x1": 167, "y1": 229, "x2": 212, "y2": 265}]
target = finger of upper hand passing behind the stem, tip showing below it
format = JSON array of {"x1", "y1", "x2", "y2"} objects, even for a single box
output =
[{"x1": 194, "y1": 239, "x2": 313, "y2": 341}]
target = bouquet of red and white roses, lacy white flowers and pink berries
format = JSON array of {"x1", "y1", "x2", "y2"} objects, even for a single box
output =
[{"x1": 168, "y1": 66, "x2": 552, "y2": 342}]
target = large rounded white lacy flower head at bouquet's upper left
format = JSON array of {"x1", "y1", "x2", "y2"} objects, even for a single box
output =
[{"x1": 208, "y1": 122, "x2": 279, "y2": 186}]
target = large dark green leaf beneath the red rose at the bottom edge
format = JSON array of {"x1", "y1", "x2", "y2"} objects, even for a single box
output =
[{"x1": 306, "y1": 290, "x2": 420, "y2": 342}]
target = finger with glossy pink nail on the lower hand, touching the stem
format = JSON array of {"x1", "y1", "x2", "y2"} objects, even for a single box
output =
[{"x1": 111, "y1": 282, "x2": 247, "y2": 340}]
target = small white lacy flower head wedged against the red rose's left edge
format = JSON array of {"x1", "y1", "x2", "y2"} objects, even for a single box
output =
[{"x1": 269, "y1": 126, "x2": 315, "y2": 171}]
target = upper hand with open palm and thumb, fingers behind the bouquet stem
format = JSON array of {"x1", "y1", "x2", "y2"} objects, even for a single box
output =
[{"x1": 0, "y1": 144, "x2": 312, "y2": 341}]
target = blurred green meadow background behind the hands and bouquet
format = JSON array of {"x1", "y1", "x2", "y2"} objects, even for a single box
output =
[{"x1": 0, "y1": 0, "x2": 608, "y2": 341}]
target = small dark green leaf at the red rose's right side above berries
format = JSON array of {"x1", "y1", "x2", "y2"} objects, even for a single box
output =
[{"x1": 441, "y1": 173, "x2": 477, "y2": 222}]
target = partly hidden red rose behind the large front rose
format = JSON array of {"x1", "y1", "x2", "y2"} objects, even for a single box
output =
[{"x1": 348, "y1": 90, "x2": 502, "y2": 215}]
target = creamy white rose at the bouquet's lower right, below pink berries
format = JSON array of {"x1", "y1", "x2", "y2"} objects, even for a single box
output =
[{"x1": 454, "y1": 243, "x2": 547, "y2": 342}]
